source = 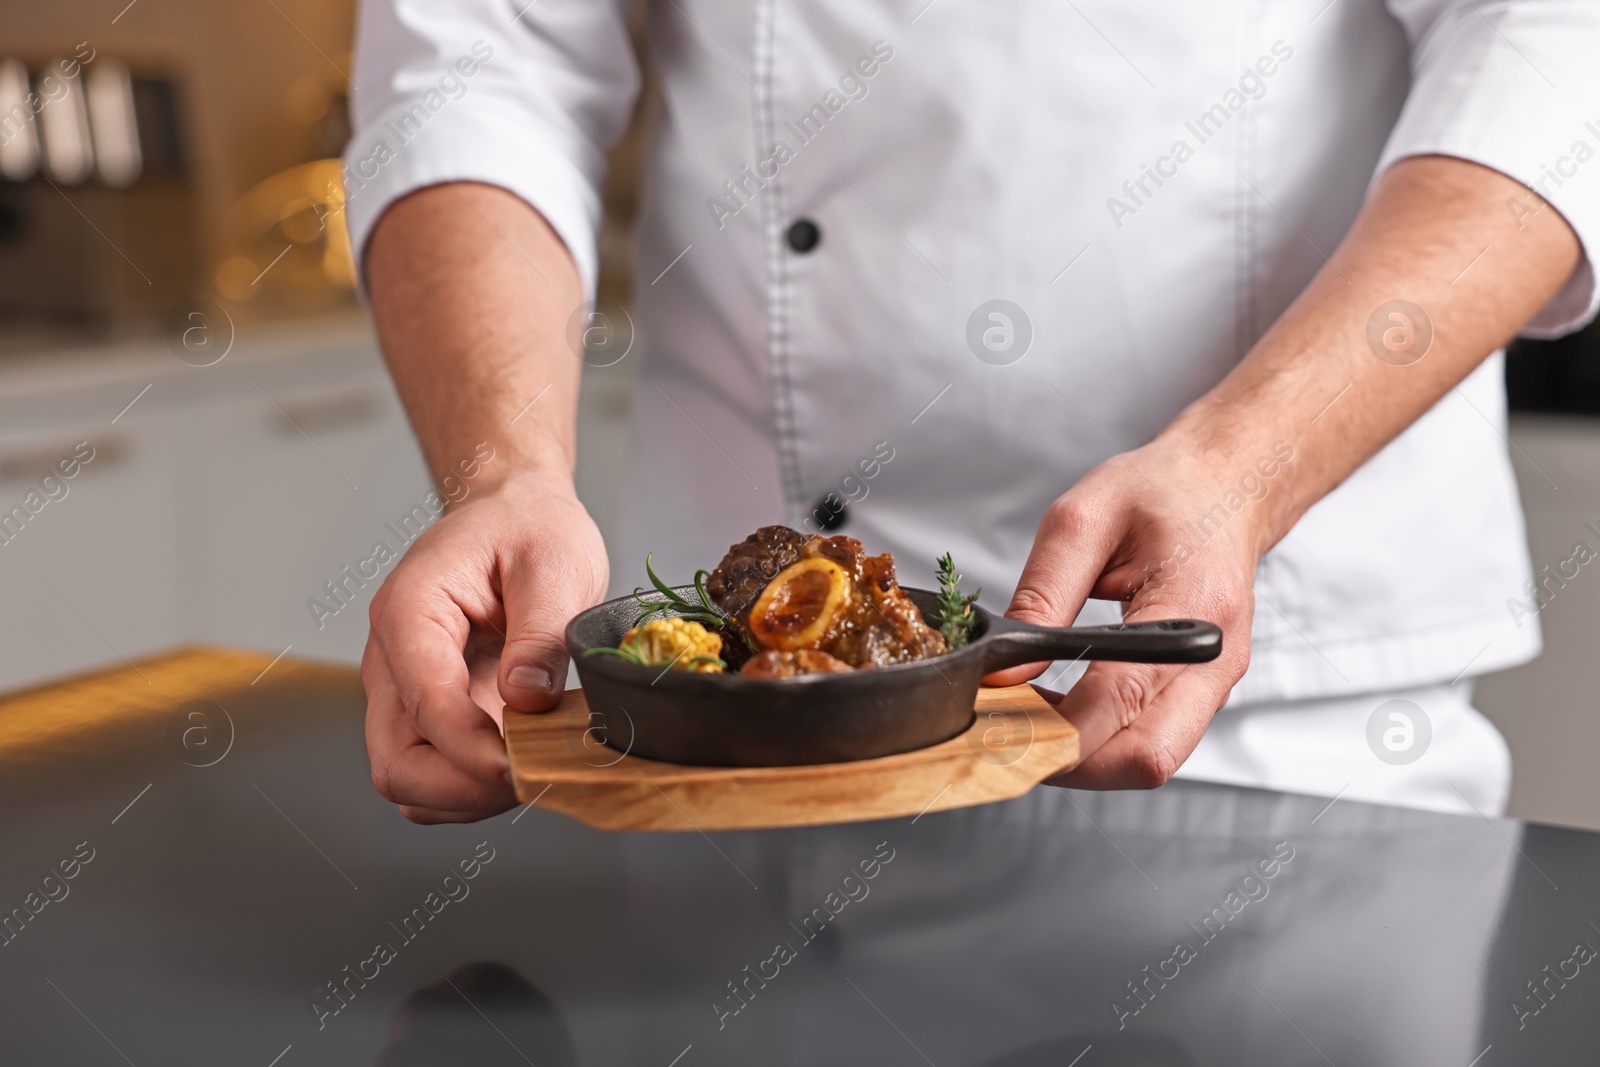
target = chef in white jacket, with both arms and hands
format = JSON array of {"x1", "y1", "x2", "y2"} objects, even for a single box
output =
[{"x1": 346, "y1": 0, "x2": 1600, "y2": 822}]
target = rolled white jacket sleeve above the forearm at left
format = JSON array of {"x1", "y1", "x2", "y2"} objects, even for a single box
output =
[{"x1": 344, "y1": 0, "x2": 638, "y2": 294}]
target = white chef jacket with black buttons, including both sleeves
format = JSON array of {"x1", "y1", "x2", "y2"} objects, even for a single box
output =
[{"x1": 346, "y1": 0, "x2": 1600, "y2": 783}]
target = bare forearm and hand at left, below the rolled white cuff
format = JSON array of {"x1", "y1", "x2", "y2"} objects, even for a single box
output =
[{"x1": 362, "y1": 182, "x2": 606, "y2": 822}]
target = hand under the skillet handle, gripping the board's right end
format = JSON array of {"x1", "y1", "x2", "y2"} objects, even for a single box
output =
[{"x1": 987, "y1": 442, "x2": 1277, "y2": 789}]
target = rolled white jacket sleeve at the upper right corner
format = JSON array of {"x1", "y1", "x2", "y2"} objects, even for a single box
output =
[{"x1": 1378, "y1": 0, "x2": 1600, "y2": 338}]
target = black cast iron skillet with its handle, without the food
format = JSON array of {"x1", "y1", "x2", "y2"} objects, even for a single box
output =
[{"x1": 566, "y1": 585, "x2": 1222, "y2": 766}]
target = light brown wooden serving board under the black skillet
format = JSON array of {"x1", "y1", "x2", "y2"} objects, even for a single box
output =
[{"x1": 504, "y1": 685, "x2": 1078, "y2": 830}]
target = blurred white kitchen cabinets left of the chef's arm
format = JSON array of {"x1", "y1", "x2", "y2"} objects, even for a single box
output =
[{"x1": 0, "y1": 325, "x2": 430, "y2": 689}]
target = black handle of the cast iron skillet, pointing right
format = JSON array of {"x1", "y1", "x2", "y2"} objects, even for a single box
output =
[{"x1": 981, "y1": 616, "x2": 1222, "y2": 673}]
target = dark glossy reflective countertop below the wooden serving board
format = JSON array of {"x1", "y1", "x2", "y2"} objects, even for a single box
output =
[{"x1": 0, "y1": 662, "x2": 1600, "y2": 1067}]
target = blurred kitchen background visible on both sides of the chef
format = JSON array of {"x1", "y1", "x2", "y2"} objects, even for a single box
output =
[{"x1": 0, "y1": 0, "x2": 1600, "y2": 827}]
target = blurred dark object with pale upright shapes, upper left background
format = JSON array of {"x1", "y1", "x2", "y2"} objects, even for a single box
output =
[{"x1": 0, "y1": 46, "x2": 200, "y2": 328}]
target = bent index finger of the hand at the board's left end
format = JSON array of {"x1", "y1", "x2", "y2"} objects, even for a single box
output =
[{"x1": 376, "y1": 585, "x2": 510, "y2": 782}]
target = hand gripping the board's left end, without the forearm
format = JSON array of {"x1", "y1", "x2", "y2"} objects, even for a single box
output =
[{"x1": 362, "y1": 474, "x2": 608, "y2": 822}]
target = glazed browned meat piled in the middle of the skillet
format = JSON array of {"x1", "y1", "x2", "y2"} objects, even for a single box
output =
[{"x1": 706, "y1": 526, "x2": 947, "y2": 667}]
